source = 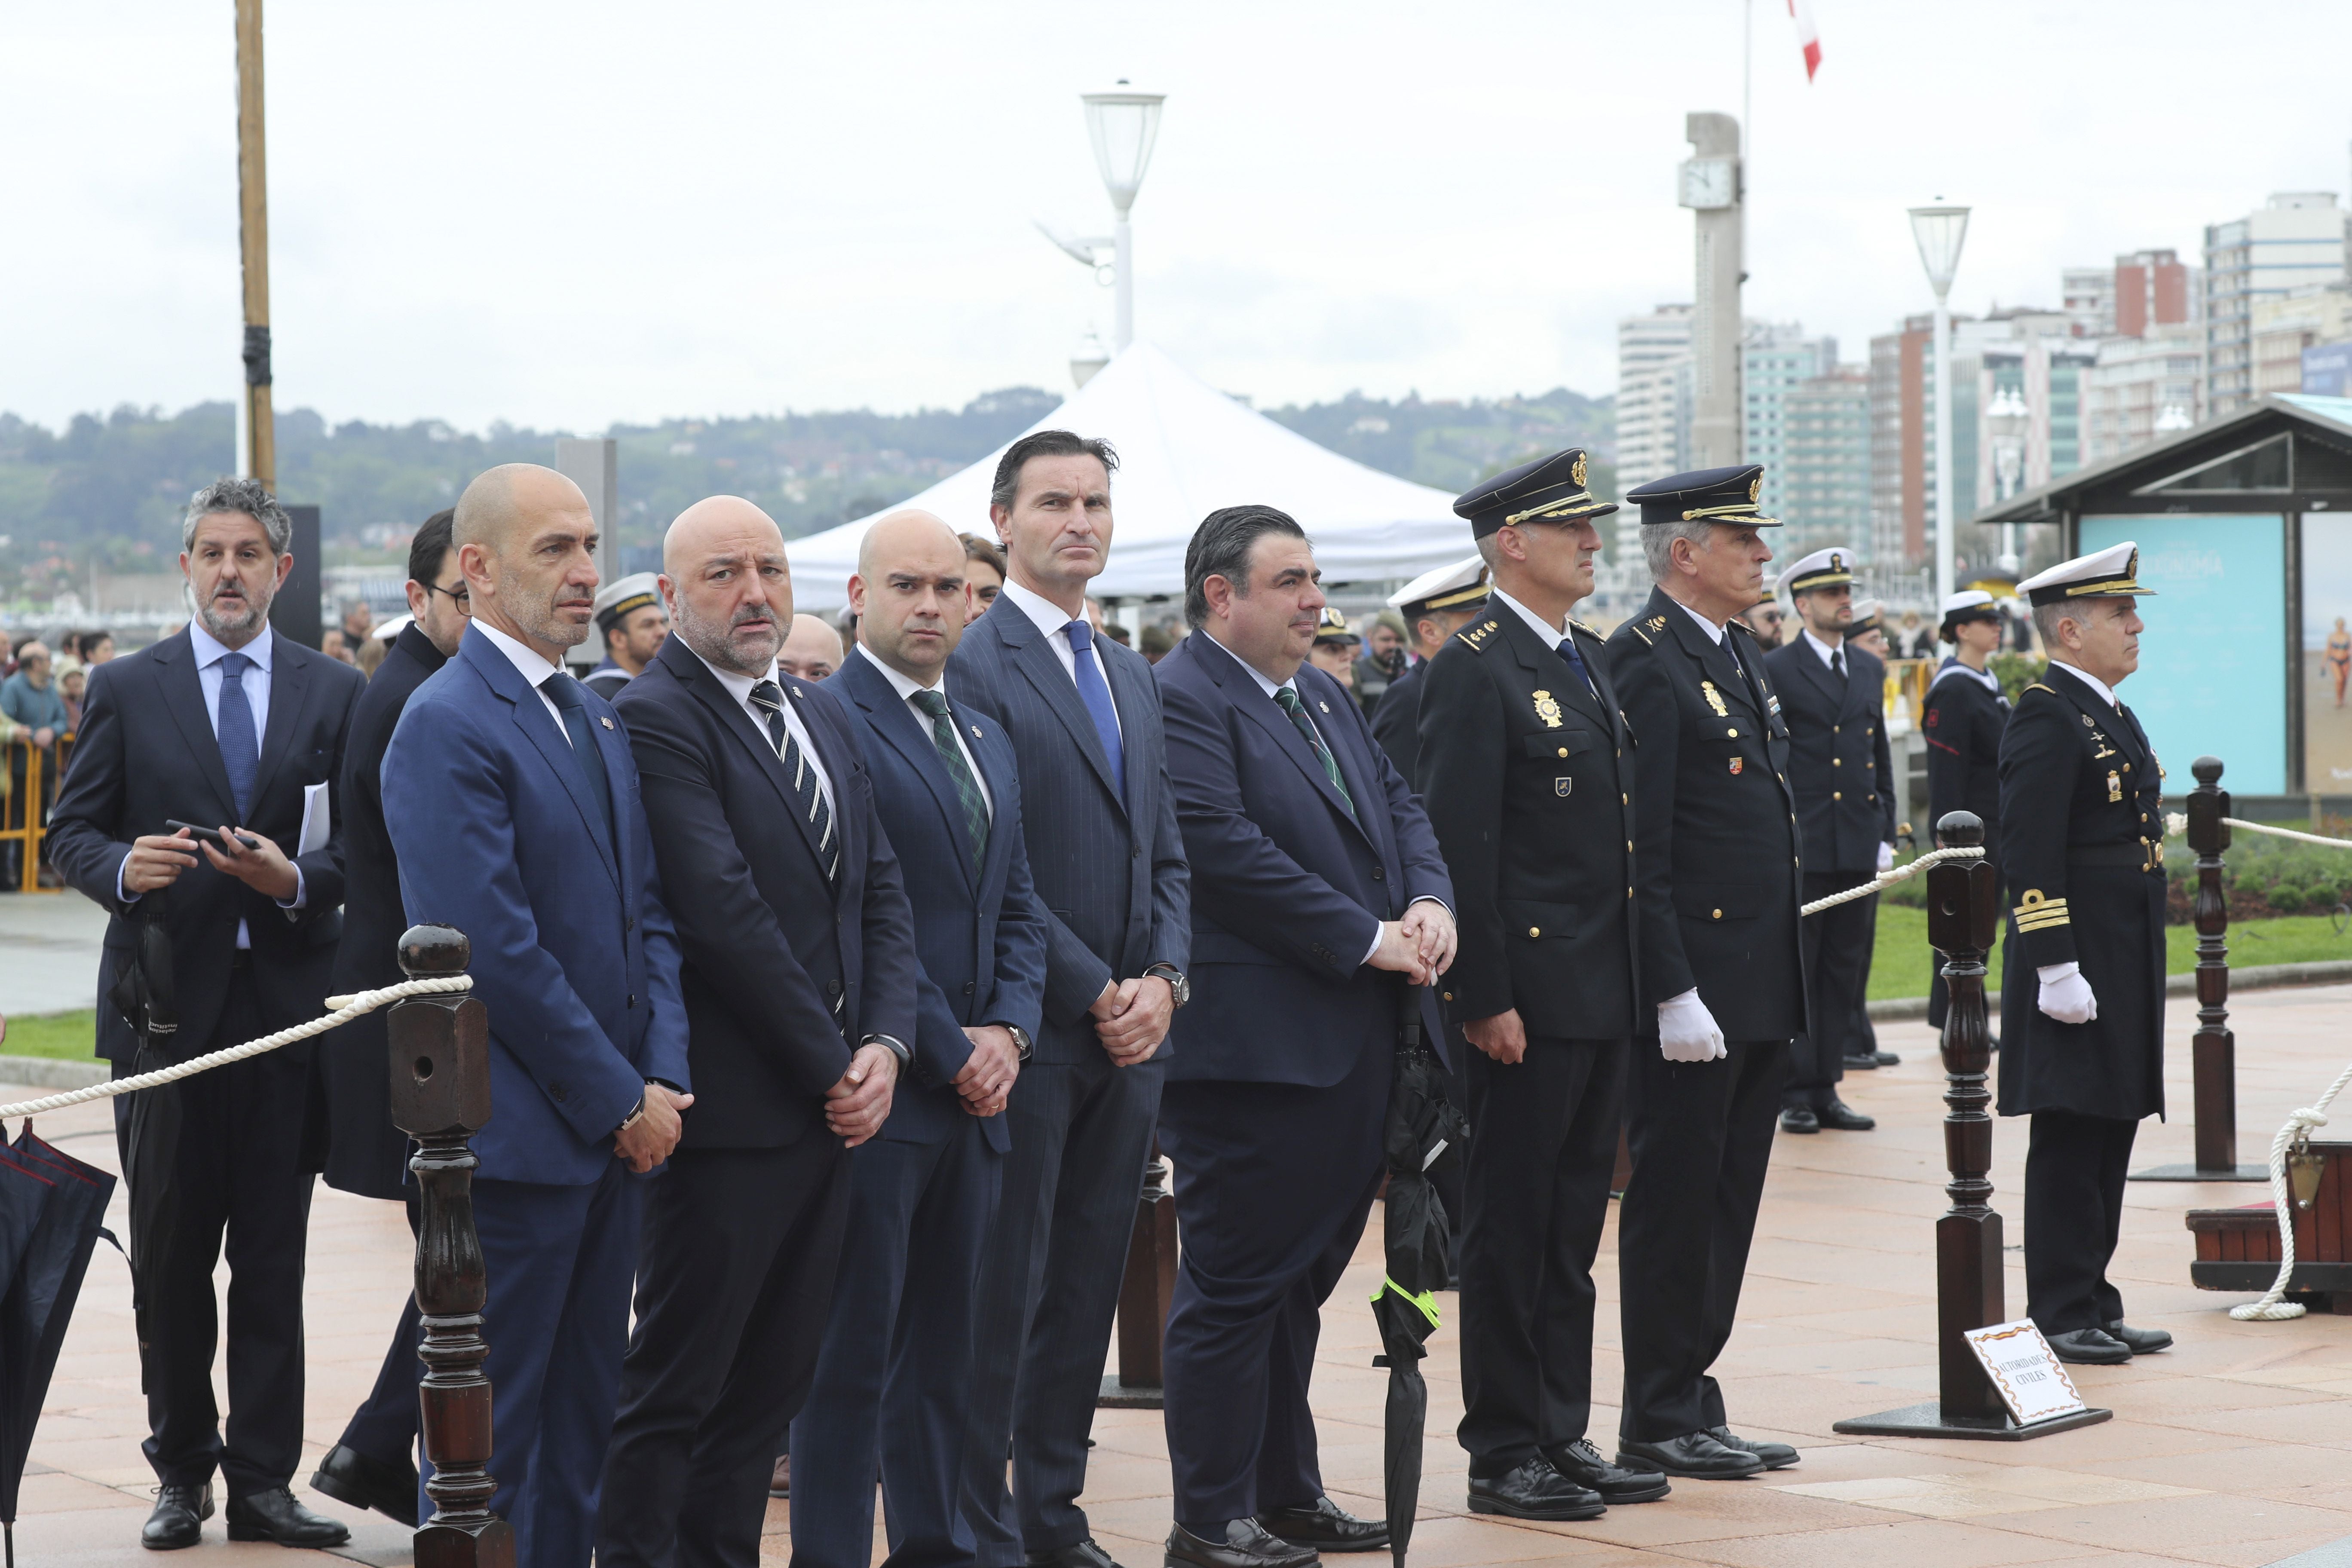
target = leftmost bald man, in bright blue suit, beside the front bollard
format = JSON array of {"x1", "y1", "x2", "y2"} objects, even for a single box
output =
[{"x1": 383, "y1": 463, "x2": 694, "y2": 1568}]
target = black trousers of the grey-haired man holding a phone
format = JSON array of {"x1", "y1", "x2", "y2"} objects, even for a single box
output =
[{"x1": 115, "y1": 966, "x2": 315, "y2": 1498}]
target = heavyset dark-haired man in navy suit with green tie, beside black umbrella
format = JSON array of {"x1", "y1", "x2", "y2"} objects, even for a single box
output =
[{"x1": 1155, "y1": 505, "x2": 1454, "y2": 1568}]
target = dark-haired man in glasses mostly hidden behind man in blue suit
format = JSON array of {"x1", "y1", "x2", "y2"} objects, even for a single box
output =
[{"x1": 310, "y1": 510, "x2": 468, "y2": 1526}]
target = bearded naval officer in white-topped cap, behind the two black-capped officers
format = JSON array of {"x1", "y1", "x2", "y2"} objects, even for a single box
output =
[{"x1": 1764, "y1": 545, "x2": 1896, "y2": 1133}]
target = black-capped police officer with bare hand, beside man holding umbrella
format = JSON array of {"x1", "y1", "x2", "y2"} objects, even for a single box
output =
[{"x1": 1421, "y1": 447, "x2": 1668, "y2": 1519}]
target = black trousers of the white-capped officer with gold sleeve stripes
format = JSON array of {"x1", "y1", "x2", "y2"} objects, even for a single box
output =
[{"x1": 2025, "y1": 1109, "x2": 2141, "y2": 1335}]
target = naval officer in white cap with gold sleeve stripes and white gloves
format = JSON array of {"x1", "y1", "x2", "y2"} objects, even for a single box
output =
[{"x1": 1999, "y1": 543, "x2": 2173, "y2": 1363}]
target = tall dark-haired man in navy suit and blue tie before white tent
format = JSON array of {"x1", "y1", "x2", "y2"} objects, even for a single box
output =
[{"x1": 948, "y1": 430, "x2": 1192, "y2": 1568}]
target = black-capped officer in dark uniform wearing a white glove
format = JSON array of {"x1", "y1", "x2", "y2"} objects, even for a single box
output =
[{"x1": 1609, "y1": 463, "x2": 1806, "y2": 1479}]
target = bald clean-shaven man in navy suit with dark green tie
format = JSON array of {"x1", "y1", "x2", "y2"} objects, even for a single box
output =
[{"x1": 793, "y1": 512, "x2": 1044, "y2": 1568}]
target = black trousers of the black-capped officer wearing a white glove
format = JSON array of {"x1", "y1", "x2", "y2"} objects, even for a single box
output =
[{"x1": 1618, "y1": 1039, "x2": 1788, "y2": 1443}]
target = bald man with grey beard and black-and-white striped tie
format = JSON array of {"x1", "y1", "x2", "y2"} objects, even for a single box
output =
[{"x1": 597, "y1": 496, "x2": 922, "y2": 1568}]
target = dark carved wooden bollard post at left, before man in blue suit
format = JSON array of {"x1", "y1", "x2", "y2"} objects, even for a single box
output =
[{"x1": 386, "y1": 926, "x2": 515, "y2": 1568}]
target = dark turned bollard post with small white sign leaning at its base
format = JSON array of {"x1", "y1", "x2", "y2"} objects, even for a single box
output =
[{"x1": 1830, "y1": 811, "x2": 2110, "y2": 1441}]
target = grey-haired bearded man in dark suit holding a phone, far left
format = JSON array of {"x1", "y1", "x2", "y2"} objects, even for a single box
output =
[{"x1": 49, "y1": 480, "x2": 367, "y2": 1549}]
